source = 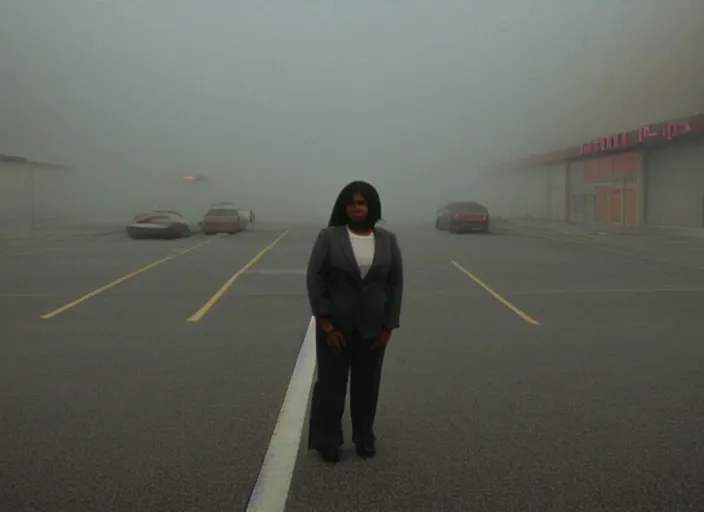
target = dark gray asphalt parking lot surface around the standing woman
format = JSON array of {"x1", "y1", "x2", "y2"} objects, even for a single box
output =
[{"x1": 0, "y1": 223, "x2": 704, "y2": 512}]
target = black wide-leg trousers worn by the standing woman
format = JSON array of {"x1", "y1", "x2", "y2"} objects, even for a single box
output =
[{"x1": 308, "y1": 329, "x2": 384, "y2": 449}]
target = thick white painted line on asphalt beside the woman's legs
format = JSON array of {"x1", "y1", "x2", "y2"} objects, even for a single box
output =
[{"x1": 247, "y1": 317, "x2": 315, "y2": 512}]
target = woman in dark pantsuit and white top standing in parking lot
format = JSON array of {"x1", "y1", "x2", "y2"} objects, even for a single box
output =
[{"x1": 307, "y1": 181, "x2": 403, "y2": 462}]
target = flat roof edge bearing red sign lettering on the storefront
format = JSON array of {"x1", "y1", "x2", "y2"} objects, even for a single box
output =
[{"x1": 495, "y1": 113, "x2": 704, "y2": 169}]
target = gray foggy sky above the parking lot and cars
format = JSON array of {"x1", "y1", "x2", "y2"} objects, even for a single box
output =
[{"x1": 0, "y1": 0, "x2": 704, "y2": 222}]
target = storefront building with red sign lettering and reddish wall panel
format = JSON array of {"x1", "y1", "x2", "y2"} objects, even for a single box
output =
[{"x1": 511, "y1": 115, "x2": 704, "y2": 228}]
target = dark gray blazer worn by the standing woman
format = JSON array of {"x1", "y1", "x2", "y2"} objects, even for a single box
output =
[{"x1": 306, "y1": 226, "x2": 403, "y2": 339}]
